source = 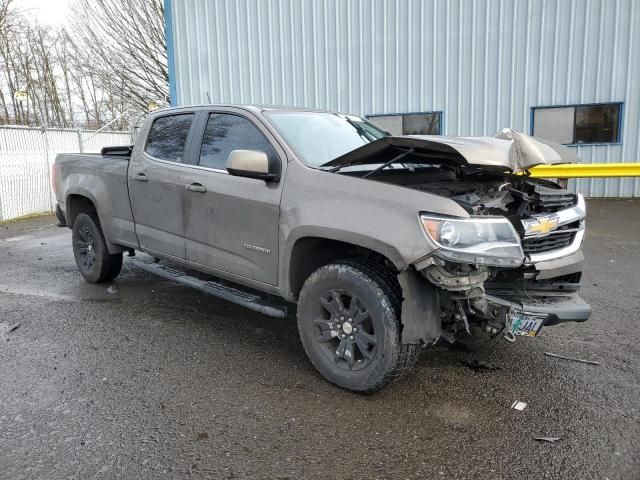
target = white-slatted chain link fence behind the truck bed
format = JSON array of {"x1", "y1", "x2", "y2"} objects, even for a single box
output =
[{"x1": 0, "y1": 126, "x2": 132, "y2": 221}]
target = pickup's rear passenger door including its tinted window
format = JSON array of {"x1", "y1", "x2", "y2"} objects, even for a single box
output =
[{"x1": 128, "y1": 113, "x2": 195, "y2": 259}]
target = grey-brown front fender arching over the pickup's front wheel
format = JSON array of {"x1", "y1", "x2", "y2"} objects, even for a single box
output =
[{"x1": 279, "y1": 160, "x2": 468, "y2": 297}]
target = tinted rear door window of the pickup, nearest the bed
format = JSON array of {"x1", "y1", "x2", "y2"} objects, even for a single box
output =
[{"x1": 144, "y1": 113, "x2": 193, "y2": 163}]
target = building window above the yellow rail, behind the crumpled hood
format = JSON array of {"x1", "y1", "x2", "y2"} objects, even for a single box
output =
[{"x1": 531, "y1": 103, "x2": 622, "y2": 145}]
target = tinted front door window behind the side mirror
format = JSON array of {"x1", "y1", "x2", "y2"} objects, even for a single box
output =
[{"x1": 199, "y1": 113, "x2": 279, "y2": 170}]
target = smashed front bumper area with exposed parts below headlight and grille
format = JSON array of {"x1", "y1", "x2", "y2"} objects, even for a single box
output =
[{"x1": 400, "y1": 246, "x2": 591, "y2": 343}]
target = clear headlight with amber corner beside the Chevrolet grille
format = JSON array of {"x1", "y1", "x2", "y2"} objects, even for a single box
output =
[{"x1": 420, "y1": 215, "x2": 524, "y2": 267}]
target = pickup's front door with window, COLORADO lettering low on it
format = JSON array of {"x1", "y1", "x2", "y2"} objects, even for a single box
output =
[{"x1": 183, "y1": 109, "x2": 285, "y2": 285}]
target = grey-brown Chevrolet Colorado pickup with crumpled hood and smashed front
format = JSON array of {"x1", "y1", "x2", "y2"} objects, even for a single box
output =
[{"x1": 53, "y1": 105, "x2": 590, "y2": 392}]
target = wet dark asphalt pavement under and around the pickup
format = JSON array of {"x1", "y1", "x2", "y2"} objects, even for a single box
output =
[{"x1": 0, "y1": 200, "x2": 640, "y2": 480}]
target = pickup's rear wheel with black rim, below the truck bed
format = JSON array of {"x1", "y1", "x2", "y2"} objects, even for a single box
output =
[{"x1": 71, "y1": 213, "x2": 122, "y2": 283}]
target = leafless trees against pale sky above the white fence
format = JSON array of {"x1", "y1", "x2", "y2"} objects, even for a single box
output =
[{"x1": 0, "y1": 0, "x2": 168, "y2": 129}]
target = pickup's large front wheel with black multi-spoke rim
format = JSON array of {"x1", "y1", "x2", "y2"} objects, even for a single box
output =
[{"x1": 298, "y1": 260, "x2": 419, "y2": 393}]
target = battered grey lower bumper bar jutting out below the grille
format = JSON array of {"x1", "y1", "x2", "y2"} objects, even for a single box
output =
[{"x1": 472, "y1": 292, "x2": 591, "y2": 326}]
